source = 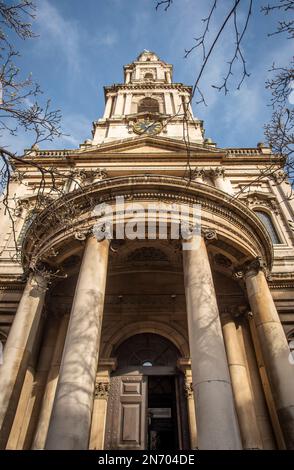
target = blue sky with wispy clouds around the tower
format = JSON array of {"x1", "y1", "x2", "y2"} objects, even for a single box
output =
[{"x1": 6, "y1": 0, "x2": 293, "y2": 152}]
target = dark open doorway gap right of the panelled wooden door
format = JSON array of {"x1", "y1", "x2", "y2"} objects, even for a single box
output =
[{"x1": 147, "y1": 376, "x2": 179, "y2": 450}]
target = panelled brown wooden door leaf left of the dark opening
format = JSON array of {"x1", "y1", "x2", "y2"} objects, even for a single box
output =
[{"x1": 105, "y1": 374, "x2": 147, "y2": 450}]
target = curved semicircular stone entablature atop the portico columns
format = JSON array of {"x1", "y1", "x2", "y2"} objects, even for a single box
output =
[{"x1": 23, "y1": 175, "x2": 272, "y2": 267}]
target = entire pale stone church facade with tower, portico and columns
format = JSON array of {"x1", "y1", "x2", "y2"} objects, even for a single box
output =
[{"x1": 0, "y1": 50, "x2": 294, "y2": 450}]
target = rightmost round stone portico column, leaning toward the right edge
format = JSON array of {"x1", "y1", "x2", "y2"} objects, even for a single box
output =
[{"x1": 245, "y1": 259, "x2": 294, "y2": 449}]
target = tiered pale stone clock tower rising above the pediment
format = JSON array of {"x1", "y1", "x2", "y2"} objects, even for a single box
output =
[{"x1": 92, "y1": 50, "x2": 203, "y2": 145}]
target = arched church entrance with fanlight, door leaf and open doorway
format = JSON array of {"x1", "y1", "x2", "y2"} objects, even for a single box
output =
[{"x1": 105, "y1": 333, "x2": 188, "y2": 450}]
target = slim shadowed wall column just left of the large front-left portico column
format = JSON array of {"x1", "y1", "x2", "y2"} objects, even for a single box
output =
[{"x1": 32, "y1": 315, "x2": 69, "y2": 450}]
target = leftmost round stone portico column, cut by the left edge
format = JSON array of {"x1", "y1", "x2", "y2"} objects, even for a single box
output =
[{"x1": 0, "y1": 273, "x2": 47, "y2": 449}]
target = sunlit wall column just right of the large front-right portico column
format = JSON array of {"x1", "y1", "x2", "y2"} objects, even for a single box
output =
[{"x1": 221, "y1": 313, "x2": 263, "y2": 450}]
